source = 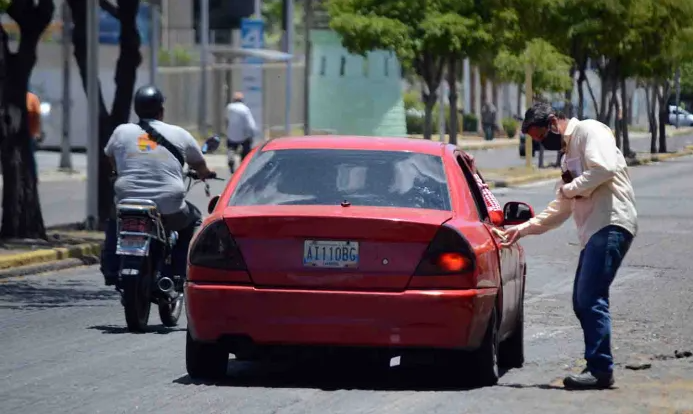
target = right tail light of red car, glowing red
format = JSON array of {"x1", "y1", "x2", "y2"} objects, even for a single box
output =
[{"x1": 414, "y1": 225, "x2": 476, "y2": 276}]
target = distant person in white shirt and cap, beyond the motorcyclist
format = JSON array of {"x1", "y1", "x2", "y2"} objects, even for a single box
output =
[{"x1": 226, "y1": 92, "x2": 257, "y2": 174}]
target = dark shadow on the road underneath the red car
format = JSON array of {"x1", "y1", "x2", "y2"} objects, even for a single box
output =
[{"x1": 173, "y1": 360, "x2": 510, "y2": 391}]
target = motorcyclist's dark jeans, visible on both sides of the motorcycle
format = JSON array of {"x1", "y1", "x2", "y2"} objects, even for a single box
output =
[{"x1": 101, "y1": 201, "x2": 202, "y2": 284}]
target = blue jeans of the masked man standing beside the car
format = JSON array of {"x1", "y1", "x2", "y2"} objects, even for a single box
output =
[{"x1": 573, "y1": 226, "x2": 633, "y2": 374}]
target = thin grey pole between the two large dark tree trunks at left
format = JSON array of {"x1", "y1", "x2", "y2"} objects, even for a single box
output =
[{"x1": 59, "y1": 2, "x2": 73, "y2": 171}]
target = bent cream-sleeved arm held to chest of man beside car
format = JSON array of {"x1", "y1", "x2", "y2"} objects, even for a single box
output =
[{"x1": 563, "y1": 128, "x2": 619, "y2": 198}]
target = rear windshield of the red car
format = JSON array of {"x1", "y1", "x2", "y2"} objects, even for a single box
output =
[{"x1": 229, "y1": 149, "x2": 450, "y2": 210}]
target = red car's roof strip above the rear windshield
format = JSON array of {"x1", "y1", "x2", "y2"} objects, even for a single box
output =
[{"x1": 262, "y1": 135, "x2": 445, "y2": 156}]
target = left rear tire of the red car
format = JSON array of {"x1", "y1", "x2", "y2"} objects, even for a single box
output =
[{"x1": 185, "y1": 331, "x2": 229, "y2": 380}]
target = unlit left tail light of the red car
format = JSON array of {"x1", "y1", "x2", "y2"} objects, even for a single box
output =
[{"x1": 190, "y1": 220, "x2": 247, "y2": 270}]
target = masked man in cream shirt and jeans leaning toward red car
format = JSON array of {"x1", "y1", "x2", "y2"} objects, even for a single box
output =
[{"x1": 504, "y1": 103, "x2": 638, "y2": 389}]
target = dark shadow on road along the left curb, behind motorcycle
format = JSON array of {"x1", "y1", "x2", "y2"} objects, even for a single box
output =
[{"x1": 0, "y1": 280, "x2": 118, "y2": 309}]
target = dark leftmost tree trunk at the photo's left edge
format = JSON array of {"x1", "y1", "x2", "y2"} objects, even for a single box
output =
[{"x1": 0, "y1": 0, "x2": 55, "y2": 239}]
